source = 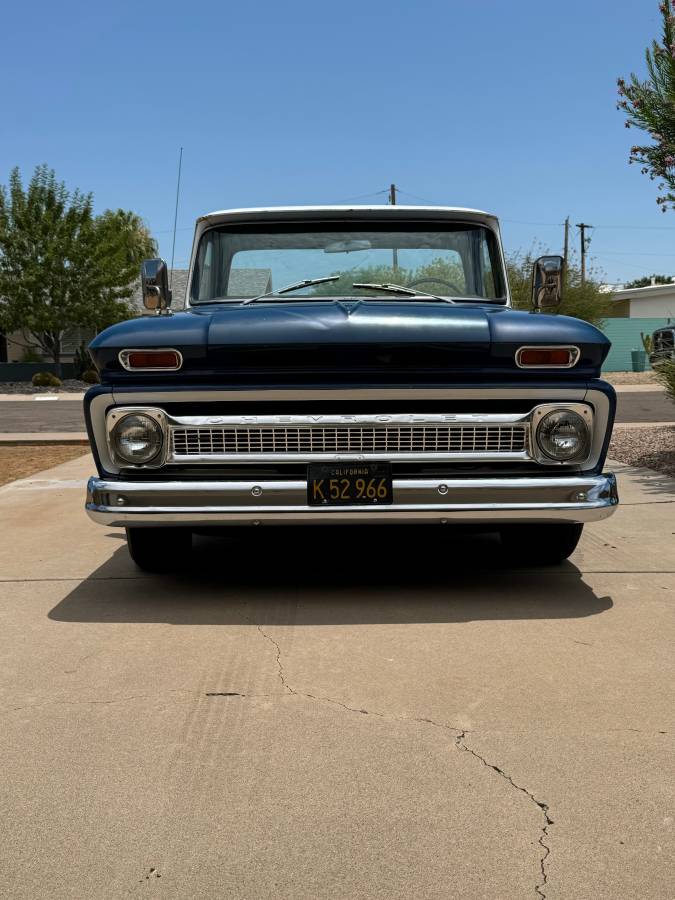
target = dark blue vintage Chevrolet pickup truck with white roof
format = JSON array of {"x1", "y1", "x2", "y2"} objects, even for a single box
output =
[{"x1": 85, "y1": 206, "x2": 618, "y2": 570}]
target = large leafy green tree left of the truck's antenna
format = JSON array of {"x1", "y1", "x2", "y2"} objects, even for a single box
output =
[{"x1": 0, "y1": 165, "x2": 156, "y2": 363}]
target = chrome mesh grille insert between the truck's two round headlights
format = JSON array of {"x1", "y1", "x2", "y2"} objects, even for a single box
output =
[{"x1": 172, "y1": 422, "x2": 528, "y2": 458}]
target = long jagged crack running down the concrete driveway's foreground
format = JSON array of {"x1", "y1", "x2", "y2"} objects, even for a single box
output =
[{"x1": 256, "y1": 625, "x2": 553, "y2": 900}]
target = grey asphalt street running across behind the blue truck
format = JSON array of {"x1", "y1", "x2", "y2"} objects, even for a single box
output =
[{"x1": 0, "y1": 390, "x2": 675, "y2": 433}]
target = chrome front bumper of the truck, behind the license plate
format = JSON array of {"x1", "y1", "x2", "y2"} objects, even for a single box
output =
[{"x1": 86, "y1": 473, "x2": 619, "y2": 528}]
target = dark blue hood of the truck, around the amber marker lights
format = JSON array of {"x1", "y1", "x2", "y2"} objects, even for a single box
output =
[{"x1": 89, "y1": 300, "x2": 610, "y2": 384}]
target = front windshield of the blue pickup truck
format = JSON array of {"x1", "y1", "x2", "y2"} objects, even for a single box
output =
[{"x1": 190, "y1": 223, "x2": 505, "y2": 303}]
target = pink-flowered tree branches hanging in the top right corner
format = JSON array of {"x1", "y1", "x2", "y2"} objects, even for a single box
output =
[{"x1": 617, "y1": 0, "x2": 675, "y2": 212}]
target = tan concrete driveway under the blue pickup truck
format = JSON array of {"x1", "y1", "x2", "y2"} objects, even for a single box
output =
[{"x1": 0, "y1": 459, "x2": 675, "y2": 900}]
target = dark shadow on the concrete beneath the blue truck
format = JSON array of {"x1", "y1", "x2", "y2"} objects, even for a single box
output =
[{"x1": 49, "y1": 528, "x2": 612, "y2": 625}]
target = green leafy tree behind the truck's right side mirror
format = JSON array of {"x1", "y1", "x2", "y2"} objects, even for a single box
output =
[{"x1": 506, "y1": 251, "x2": 612, "y2": 325}]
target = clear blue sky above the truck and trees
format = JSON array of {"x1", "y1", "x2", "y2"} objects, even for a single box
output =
[{"x1": 0, "y1": 0, "x2": 675, "y2": 281}]
